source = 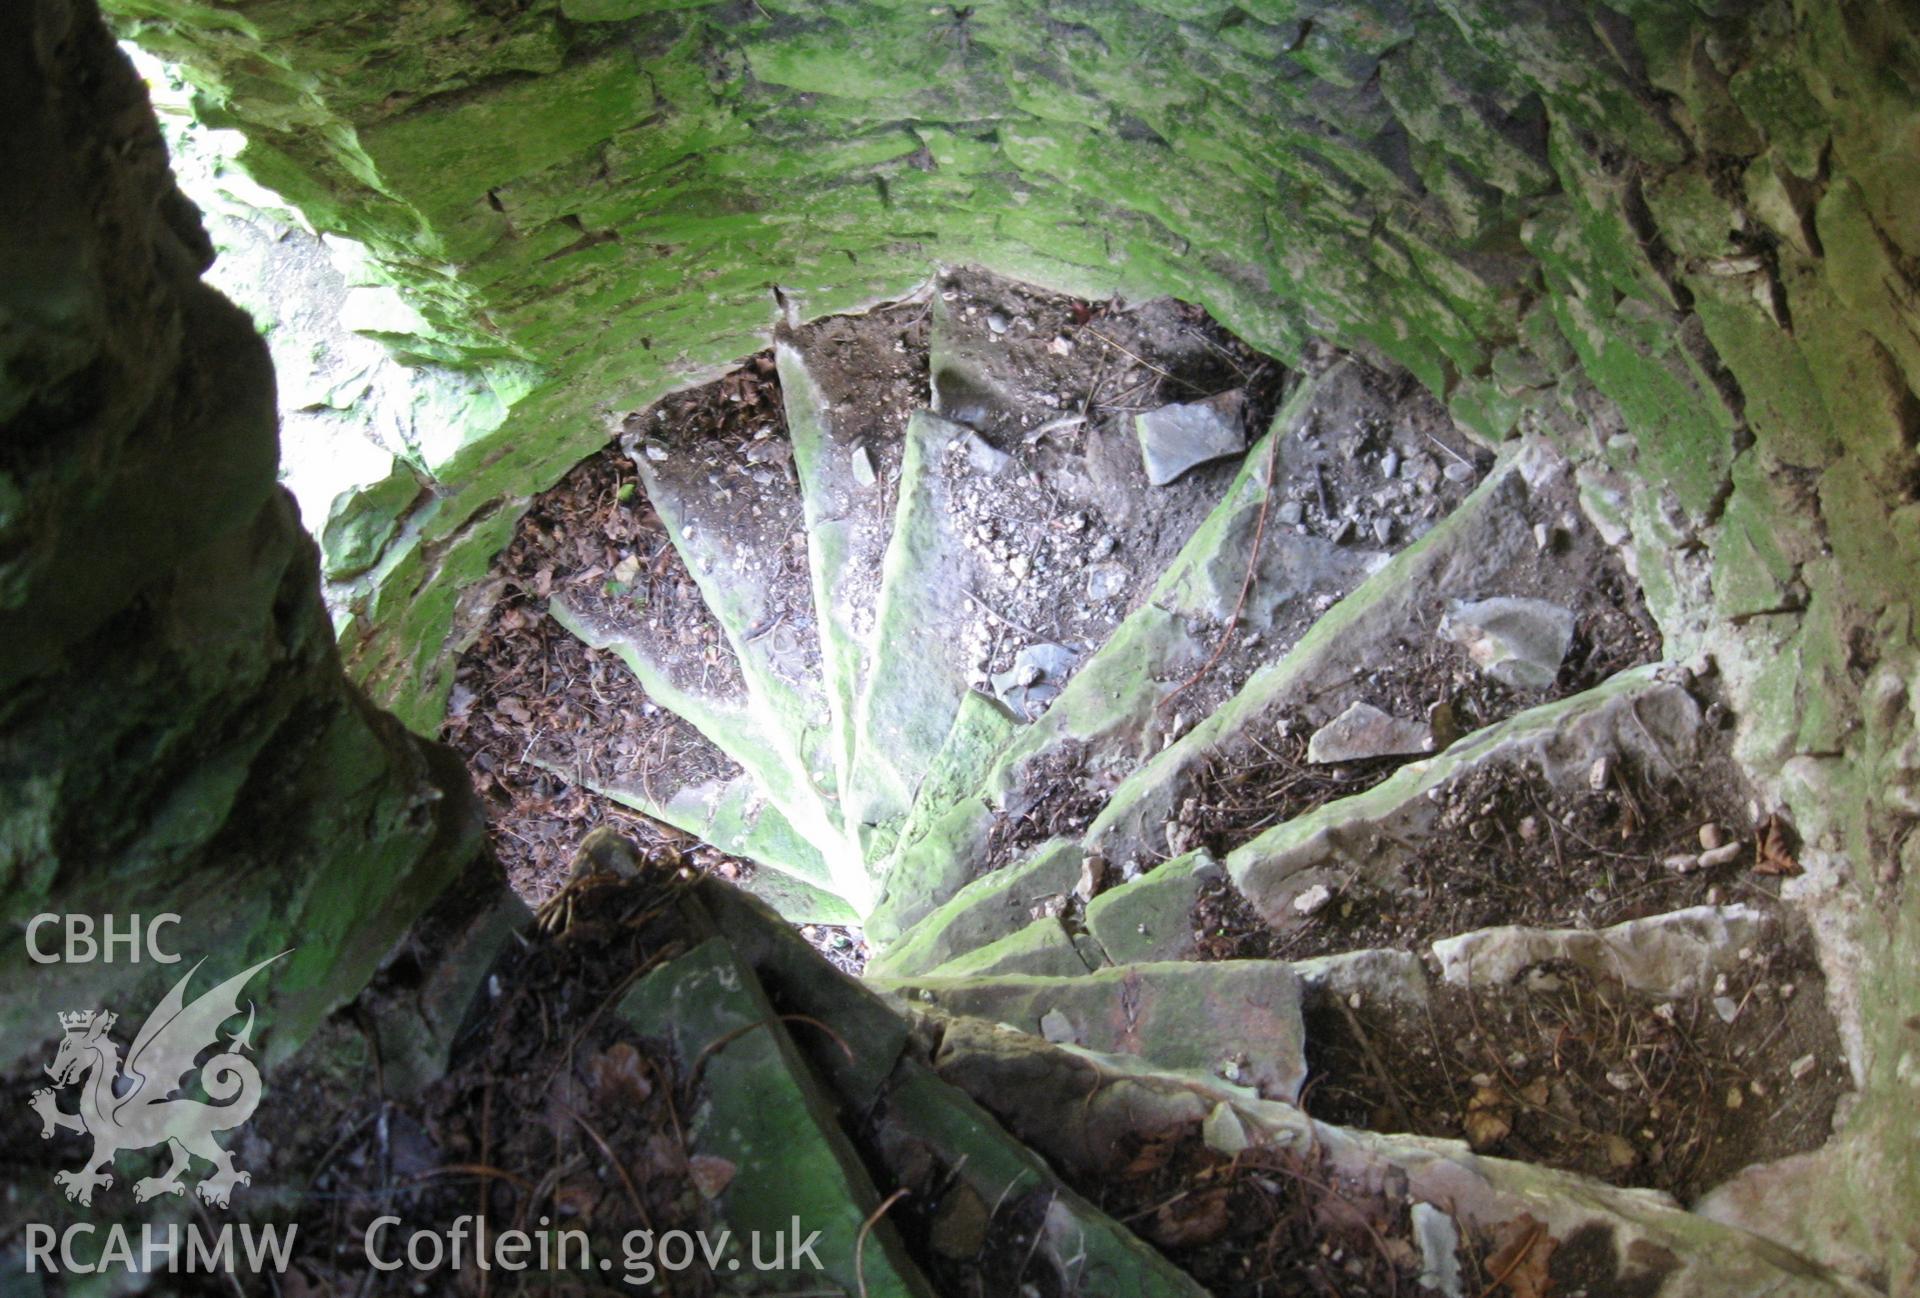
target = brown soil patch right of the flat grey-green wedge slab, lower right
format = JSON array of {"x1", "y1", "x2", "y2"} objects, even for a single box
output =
[{"x1": 1302, "y1": 937, "x2": 1849, "y2": 1202}]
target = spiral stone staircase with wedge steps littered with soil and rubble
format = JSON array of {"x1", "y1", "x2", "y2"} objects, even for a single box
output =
[{"x1": 480, "y1": 271, "x2": 1847, "y2": 1294}]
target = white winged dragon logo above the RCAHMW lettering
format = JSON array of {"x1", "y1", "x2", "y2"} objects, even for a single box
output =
[{"x1": 29, "y1": 950, "x2": 286, "y2": 1208}]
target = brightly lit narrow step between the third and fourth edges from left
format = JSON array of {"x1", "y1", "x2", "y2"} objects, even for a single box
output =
[{"x1": 620, "y1": 389, "x2": 839, "y2": 856}]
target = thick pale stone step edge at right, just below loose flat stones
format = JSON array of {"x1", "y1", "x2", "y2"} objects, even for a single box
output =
[{"x1": 1227, "y1": 666, "x2": 1703, "y2": 941}]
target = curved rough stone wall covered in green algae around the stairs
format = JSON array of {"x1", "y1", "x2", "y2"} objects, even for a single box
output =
[{"x1": 26, "y1": 0, "x2": 1920, "y2": 1288}]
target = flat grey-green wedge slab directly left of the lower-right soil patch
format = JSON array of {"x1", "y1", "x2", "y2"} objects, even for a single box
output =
[{"x1": 877, "y1": 960, "x2": 1308, "y2": 1104}]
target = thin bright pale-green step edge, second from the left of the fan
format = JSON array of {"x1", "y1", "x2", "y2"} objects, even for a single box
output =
[{"x1": 547, "y1": 597, "x2": 872, "y2": 914}]
